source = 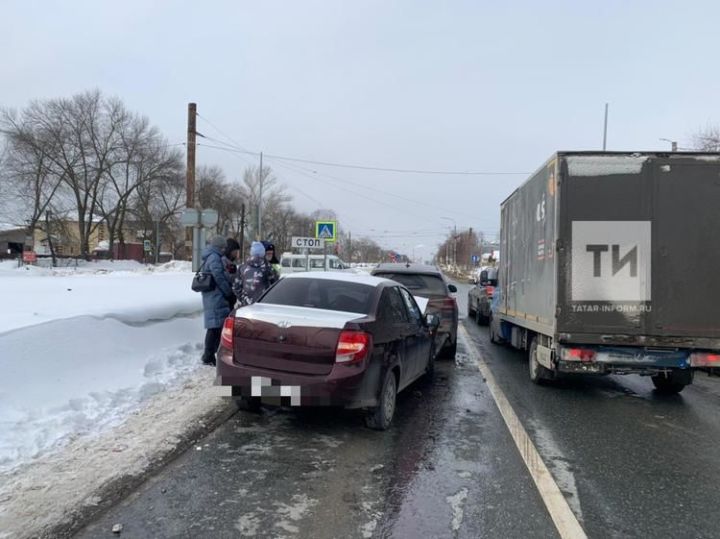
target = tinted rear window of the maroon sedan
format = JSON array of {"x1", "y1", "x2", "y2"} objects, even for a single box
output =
[{"x1": 259, "y1": 278, "x2": 375, "y2": 314}]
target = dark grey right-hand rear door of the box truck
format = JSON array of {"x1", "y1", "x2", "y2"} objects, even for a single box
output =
[{"x1": 645, "y1": 157, "x2": 720, "y2": 338}]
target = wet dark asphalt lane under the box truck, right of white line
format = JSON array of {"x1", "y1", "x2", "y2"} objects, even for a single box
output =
[{"x1": 465, "y1": 288, "x2": 720, "y2": 538}]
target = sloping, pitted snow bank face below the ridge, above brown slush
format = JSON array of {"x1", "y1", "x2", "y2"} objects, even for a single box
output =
[{"x1": 0, "y1": 317, "x2": 203, "y2": 472}]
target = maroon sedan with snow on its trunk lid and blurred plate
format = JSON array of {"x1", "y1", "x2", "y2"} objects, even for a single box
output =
[{"x1": 216, "y1": 272, "x2": 439, "y2": 430}]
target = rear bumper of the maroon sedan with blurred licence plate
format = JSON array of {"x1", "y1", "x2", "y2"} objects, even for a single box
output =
[{"x1": 215, "y1": 347, "x2": 380, "y2": 408}]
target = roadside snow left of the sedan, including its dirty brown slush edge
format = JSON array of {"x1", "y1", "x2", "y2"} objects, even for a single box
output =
[{"x1": 0, "y1": 262, "x2": 228, "y2": 539}]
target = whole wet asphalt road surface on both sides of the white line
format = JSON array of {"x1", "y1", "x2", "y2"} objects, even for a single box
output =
[{"x1": 73, "y1": 284, "x2": 720, "y2": 538}]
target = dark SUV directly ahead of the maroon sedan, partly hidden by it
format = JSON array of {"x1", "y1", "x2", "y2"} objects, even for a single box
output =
[{"x1": 371, "y1": 263, "x2": 458, "y2": 359}]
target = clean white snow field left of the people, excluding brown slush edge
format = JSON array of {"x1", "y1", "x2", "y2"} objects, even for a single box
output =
[{"x1": 0, "y1": 262, "x2": 203, "y2": 473}]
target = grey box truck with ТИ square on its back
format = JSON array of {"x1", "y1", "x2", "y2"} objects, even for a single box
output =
[{"x1": 490, "y1": 152, "x2": 720, "y2": 393}]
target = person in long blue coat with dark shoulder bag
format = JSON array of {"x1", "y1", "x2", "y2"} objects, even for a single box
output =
[{"x1": 202, "y1": 236, "x2": 234, "y2": 365}]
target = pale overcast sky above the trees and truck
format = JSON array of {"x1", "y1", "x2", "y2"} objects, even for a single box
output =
[{"x1": 0, "y1": 0, "x2": 720, "y2": 257}]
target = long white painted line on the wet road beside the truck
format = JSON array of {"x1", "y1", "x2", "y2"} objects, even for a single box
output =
[{"x1": 458, "y1": 325, "x2": 587, "y2": 539}]
